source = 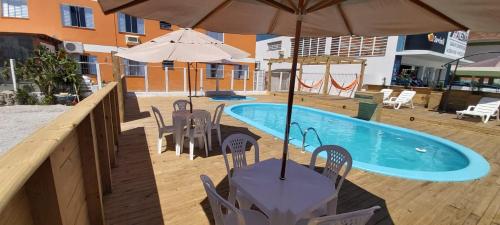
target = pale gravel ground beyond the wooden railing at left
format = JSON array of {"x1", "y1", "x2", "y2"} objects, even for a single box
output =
[{"x1": 0, "y1": 105, "x2": 71, "y2": 155}]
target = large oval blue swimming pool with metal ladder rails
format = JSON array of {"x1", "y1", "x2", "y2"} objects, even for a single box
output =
[{"x1": 224, "y1": 103, "x2": 489, "y2": 181}]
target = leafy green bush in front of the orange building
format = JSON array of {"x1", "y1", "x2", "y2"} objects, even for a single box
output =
[{"x1": 8, "y1": 46, "x2": 82, "y2": 104}]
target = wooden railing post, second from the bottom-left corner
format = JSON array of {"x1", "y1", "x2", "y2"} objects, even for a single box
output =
[{"x1": 77, "y1": 115, "x2": 105, "y2": 225}]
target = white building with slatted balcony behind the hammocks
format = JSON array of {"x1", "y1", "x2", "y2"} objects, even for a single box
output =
[{"x1": 256, "y1": 32, "x2": 467, "y2": 94}]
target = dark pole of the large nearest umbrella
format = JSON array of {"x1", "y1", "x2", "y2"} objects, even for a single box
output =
[{"x1": 280, "y1": 12, "x2": 303, "y2": 180}]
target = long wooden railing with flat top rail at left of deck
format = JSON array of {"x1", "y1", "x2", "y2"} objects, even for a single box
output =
[{"x1": 0, "y1": 82, "x2": 122, "y2": 225}]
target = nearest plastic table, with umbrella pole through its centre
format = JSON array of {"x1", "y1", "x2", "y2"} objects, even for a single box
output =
[{"x1": 231, "y1": 159, "x2": 335, "y2": 225}]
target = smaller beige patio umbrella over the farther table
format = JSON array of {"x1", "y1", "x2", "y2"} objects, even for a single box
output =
[{"x1": 116, "y1": 28, "x2": 250, "y2": 110}]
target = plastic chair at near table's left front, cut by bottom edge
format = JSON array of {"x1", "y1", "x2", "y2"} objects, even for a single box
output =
[{"x1": 200, "y1": 175, "x2": 269, "y2": 225}]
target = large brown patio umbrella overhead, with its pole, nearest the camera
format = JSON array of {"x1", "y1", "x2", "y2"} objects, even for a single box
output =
[{"x1": 99, "y1": 0, "x2": 500, "y2": 179}]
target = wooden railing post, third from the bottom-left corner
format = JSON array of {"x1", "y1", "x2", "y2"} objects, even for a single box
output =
[{"x1": 92, "y1": 101, "x2": 112, "y2": 193}]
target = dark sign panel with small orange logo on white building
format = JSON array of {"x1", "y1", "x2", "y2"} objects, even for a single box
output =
[{"x1": 405, "y1": 32, "x2": 448, "y2": 53}]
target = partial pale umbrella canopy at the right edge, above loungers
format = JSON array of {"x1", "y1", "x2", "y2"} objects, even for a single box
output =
[{"x1": 455, "y1": 56, "x2": 500, "y2": 78}]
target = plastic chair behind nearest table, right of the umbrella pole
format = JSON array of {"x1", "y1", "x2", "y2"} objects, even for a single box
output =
[{"x1": 309, "y1": 145, "x2": 352, "y2": 215}]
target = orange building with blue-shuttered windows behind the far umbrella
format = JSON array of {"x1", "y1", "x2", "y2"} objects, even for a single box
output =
[{"x1": 0, "y1": 0, "x2": 256, "y2": 93}]
